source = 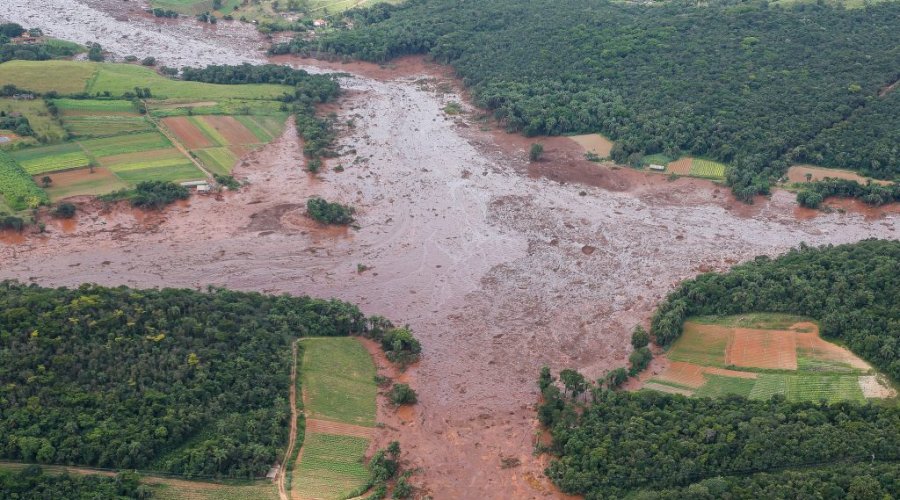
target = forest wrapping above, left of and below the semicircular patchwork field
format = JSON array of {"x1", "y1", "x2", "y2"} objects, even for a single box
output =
[{"x1": 538, "y1": 240, "x2": 900, "y2": 499}]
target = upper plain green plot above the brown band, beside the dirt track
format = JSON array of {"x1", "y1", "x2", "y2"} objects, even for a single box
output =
[{"x1": 301, "y1": 337, "x2": 377, "y2": 427}]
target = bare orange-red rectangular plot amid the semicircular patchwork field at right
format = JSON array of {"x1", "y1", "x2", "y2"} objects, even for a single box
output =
[{"x1": 725, "y1": 328, "x2": 797, "y2": 370}]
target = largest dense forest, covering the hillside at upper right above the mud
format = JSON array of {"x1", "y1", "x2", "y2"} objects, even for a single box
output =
[{"x1": 273, "y1": 0, "x2": 900, "y2": 199}]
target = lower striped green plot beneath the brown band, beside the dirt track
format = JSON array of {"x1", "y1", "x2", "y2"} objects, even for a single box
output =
[{"x1": 292, "y1": 434, "x2": 369, "y2": 499}]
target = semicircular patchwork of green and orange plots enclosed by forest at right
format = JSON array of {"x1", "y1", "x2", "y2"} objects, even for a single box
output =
[{"x1": 644, "y1": 314, "x2": 896, "y2": 401}]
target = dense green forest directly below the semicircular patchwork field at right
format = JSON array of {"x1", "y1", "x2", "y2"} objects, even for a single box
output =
[{"x1": 544, "y1": 390, "x2": 900, "y2": 499}]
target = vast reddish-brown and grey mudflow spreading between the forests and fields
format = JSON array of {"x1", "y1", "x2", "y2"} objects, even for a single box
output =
[{"x1": 0, "y1": 0, "x2": 897, "y2": 499}]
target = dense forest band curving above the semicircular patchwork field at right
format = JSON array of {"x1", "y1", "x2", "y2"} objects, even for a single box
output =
[{"x1": 652, "y1": 240, "x2": 900, "y2": 380}]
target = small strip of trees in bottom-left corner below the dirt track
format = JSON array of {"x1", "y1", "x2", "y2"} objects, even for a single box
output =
[{"x1": 0, "y1": 465, "x2": 152, "y2": 500}]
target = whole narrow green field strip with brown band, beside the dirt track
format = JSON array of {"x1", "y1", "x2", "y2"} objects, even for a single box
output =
[{"x1": 291, "y1": 337, "x2": 378, "y2": 498}]
